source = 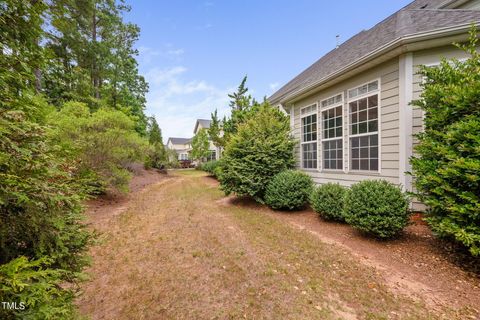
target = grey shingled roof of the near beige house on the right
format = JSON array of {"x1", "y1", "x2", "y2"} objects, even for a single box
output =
[{"x1": 268, "y1": 4, "x2": 480, "y2": 103}]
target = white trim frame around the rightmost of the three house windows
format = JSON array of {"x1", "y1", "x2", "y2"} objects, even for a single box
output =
[{"x1": 346, "y1": 78, "x2": 382, "y2": 174}]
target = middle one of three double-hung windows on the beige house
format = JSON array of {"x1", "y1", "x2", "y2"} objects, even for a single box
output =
[{"x1": 321, "y1": 94, "x2": 343, "y2": 170}]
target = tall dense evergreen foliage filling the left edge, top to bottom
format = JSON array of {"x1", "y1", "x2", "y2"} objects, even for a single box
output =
[{"x1": 0, "y1": 0, "x2": 90, "y2": 319}]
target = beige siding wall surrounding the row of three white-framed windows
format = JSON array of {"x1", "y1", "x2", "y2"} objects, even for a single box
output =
[{"x1": 290, "y1": 58, "x2": 399, "y2": 186}]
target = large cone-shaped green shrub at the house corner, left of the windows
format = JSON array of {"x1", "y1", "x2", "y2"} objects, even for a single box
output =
[{"x1": 219, "y1": 103, "x2": 295, "y2": 202}]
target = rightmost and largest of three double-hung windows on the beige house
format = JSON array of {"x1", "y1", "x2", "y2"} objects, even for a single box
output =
[{"x1": 348, "y1": 80, "x2": 379, "y2": 171}]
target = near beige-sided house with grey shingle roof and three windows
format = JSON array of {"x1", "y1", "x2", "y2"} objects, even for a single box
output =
[{"x1": 268, "y1": 0, "x2": 480, "y2": 209}]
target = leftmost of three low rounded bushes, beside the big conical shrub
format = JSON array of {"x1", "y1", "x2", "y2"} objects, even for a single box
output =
[{"x1": 265, "y1": 170, "x2": 313, "y2": 210}]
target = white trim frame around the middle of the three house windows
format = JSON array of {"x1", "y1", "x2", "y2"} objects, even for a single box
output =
[{"x1": 317, "y1": 91, "x2": 348, "y2": 173}]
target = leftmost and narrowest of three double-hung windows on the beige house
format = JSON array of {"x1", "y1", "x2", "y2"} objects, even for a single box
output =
[{"x1": 300, "y1": 104, "x2": 317, "y2": 169}]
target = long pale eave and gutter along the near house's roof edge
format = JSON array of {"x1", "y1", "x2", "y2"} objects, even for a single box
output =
[{"x1": 270, "y1": 22, "x2": 480, "y2": 105}]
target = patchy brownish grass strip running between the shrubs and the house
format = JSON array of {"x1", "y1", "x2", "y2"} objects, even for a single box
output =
[{"x1": 78, "y1": 175, "x2": 469, "y2": 319}]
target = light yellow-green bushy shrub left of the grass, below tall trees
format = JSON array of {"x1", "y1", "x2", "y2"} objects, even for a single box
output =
[{"x1": 49, "y1": 102, "x2": 147, "y2": 193}]
